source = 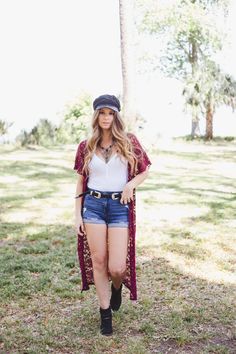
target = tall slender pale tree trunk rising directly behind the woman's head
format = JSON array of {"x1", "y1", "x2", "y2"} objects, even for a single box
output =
[{"x1": 119, "y1": 0, "x2": 136, "y2": 131}]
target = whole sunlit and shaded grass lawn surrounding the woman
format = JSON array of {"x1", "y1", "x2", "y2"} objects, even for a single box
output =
[{"x1": 0, "y1": 141, "x2": 236, "y2": 354}]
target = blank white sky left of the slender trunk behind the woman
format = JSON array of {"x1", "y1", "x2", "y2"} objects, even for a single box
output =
[{"x1": 0, "y1": 0, "x2": 121, "y2": 138}]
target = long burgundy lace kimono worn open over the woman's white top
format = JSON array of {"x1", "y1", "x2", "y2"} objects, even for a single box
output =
[{"x1": 74, "y1": 134, "x2": 151, "y2": 300}]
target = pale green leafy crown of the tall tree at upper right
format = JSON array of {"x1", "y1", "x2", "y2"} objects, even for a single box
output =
[{"x1": 141, "y1": 1, "x2": 225, "y2": 76}]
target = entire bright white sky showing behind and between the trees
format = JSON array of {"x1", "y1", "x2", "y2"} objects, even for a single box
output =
[{"x1": 0, "y1": 0, "x2": 236, "y2": 141}]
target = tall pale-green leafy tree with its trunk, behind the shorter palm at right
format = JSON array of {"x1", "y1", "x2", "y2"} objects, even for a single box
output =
[{"x1": 139, "y1": 0, "x2": 228, "y2": 137}]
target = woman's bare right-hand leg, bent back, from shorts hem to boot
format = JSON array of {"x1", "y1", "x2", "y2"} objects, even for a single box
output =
[{"x1": 108, "y1": 227, "x2": 129, "y2": 289}]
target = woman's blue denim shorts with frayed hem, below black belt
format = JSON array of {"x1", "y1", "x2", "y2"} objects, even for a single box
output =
[{"x1": 82, "y1": 192, "x2": 129, "y2": 227}]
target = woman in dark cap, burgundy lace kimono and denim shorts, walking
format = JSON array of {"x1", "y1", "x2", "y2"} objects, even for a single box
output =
[{"x1": 74, "y1": 95, "x2": 151, "y2": 335}]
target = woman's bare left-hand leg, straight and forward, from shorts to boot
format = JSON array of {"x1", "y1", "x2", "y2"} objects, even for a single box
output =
[{"x1": 85, "y1": 224, "x2": 110, "y2": 309}]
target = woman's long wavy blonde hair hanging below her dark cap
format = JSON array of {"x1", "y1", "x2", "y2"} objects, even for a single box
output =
[{"x1": 83, "y1": 110, "x2": 138, "y2": 174}]
